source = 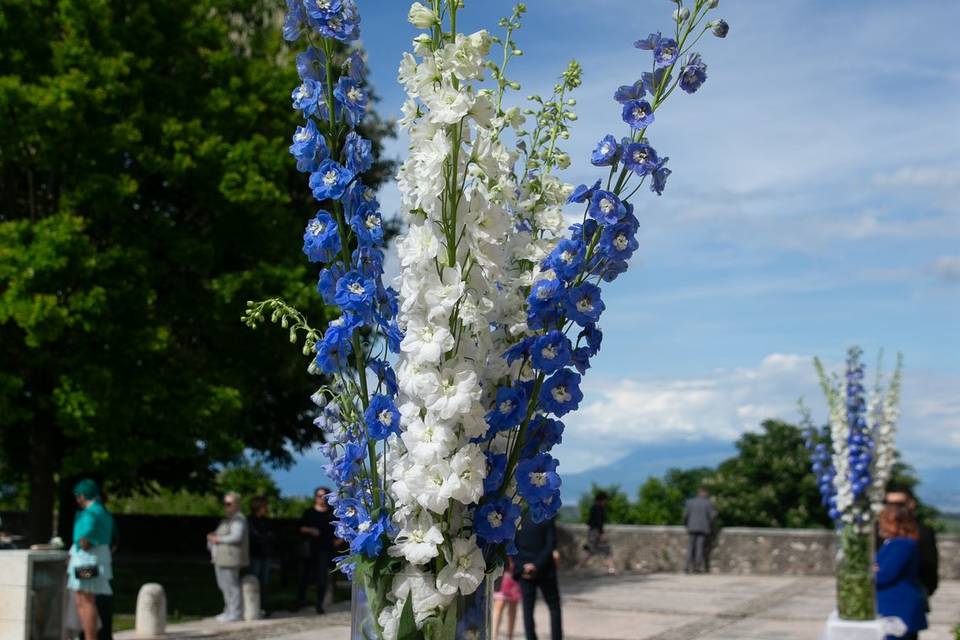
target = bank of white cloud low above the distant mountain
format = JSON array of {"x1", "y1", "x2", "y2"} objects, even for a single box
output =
[{"x1": 558, "y1": 353, "x2": 960, "y2": 473}]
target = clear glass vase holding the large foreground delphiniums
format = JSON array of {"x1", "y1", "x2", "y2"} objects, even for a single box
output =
[{"x1": 350, "y1": 577, "x2": 493, "y2": 640}]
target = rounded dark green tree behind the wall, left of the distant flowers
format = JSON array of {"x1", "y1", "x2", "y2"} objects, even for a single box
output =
[{"x1": 704, "y1": 420, "x2": 831, "y2": 527}]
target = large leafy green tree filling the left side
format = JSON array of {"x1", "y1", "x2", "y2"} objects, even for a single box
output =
[{"x1": 0, "y1": 0, "x2": 389, "y2": 540}]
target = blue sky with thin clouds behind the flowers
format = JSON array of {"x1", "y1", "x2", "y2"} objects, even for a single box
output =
[{"x1": 278, "y1": 0, "x2": 960, "y2": 504}]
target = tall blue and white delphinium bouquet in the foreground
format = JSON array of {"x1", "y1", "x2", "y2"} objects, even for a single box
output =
[{"x1": 247, "y1": 0, "x2": 728, "y2": 640}]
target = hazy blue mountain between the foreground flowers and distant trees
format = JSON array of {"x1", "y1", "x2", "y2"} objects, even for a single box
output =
[{"x1": 559, "y1": 440, "x2": 736, "y2": 505}]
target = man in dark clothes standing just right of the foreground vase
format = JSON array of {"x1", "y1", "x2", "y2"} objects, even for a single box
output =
[{"x1": 513, "y1": 513, "x2": 563, "y2": 640}]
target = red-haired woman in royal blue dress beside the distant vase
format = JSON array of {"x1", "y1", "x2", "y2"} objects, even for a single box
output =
[{"x1": 875, "y1": 504, "x2": 927, "y2": 640}]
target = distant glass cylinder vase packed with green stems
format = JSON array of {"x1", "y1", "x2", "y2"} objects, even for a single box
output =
[{"x1": 837, "y1": 525, "x2": 877, "y2": 620}]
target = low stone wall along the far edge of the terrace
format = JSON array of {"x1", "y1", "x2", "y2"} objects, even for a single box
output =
[{"x1": 558, "y1": 524, "x2": 960, "y2": 580}]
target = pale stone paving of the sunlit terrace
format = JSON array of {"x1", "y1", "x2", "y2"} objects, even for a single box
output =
[{"x1": 118, "y1": 574, "x2": 960, "y2": 640}]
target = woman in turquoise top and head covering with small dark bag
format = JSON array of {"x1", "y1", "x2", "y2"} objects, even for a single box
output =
[{"x1": 67, "y1": 480, "x2": 113, "y2": 640}]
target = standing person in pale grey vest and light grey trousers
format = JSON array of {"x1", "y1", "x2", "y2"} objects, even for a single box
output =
[{"x1": 207, "y1": 491, "x2": 250, "y2": 622}]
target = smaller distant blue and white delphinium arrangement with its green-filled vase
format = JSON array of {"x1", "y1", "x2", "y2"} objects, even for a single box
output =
[{"x1": 803, "y1": 347, "x2": 902, "y2": 620}]
